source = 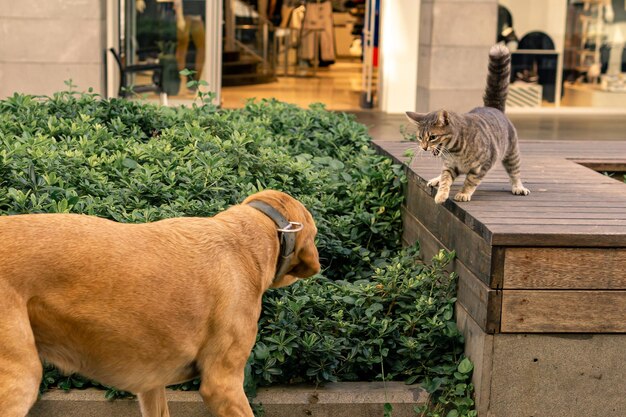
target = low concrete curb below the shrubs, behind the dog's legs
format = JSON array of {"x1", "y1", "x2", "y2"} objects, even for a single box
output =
[{"x1": 28, "y1": 382, "x2": 428, "y2": 417}]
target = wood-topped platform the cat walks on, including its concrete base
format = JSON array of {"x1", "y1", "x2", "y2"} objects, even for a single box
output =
[{"x1": 377, "y1": 141, "x2": 626, "y2": 417}]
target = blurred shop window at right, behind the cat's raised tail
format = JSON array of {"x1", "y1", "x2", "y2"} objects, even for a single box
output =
[{"x1": 498, "y1": 0, "x2": 626, "y2": 109}]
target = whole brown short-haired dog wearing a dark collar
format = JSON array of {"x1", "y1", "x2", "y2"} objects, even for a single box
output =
[{"x1": 0, "y1": 191, "x2": 320, "y2": 417}]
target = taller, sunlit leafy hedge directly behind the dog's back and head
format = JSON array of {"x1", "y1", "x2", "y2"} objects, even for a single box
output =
[{"x1": 0, "y1": 94, "x2": 404, "y2": 278}]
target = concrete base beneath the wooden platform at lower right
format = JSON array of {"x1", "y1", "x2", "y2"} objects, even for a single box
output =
[{"x1": 457, "y1": 307, "x2": 626, "y2": 417}]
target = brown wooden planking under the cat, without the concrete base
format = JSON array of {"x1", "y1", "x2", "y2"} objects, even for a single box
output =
[{"x1": 375, "y1": 141, "x2": 626, "y2": 333}]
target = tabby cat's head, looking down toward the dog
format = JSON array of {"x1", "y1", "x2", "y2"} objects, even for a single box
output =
[{"x1": 406, "y1": 110, "x2": 454, "y2": 156}]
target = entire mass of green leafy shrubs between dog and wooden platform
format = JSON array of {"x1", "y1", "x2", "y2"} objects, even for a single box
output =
[{"x1": 0, "y1": 92, "x2": 471, "y2": 412}]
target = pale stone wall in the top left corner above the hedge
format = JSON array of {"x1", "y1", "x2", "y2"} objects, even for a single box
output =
[{"x1": 0, "y1": 0, "x2": 106, "y2": 99}]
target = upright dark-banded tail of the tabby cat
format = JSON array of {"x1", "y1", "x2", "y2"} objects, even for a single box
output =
[{"x1": 483, "y1": 44, "x2": 511, "y2": 111}]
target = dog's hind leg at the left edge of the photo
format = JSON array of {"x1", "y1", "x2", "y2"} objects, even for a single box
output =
[{"x1": 0, "y1": 298, "x2": 42, "y2": 417}]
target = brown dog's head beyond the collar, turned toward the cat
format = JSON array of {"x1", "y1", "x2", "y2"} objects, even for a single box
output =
[{"x1": 243, "y1": 190, "x2": 320, "y2": 288}]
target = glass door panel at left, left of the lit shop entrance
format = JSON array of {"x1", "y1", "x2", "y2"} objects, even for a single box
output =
[{"x1": 111, "y1": 0, "x2": 222, "y2": 104}]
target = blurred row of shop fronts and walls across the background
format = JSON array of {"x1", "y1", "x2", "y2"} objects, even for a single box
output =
[{"x1": 0, "y1": 0, "x2": 626, "y2": 114}]
